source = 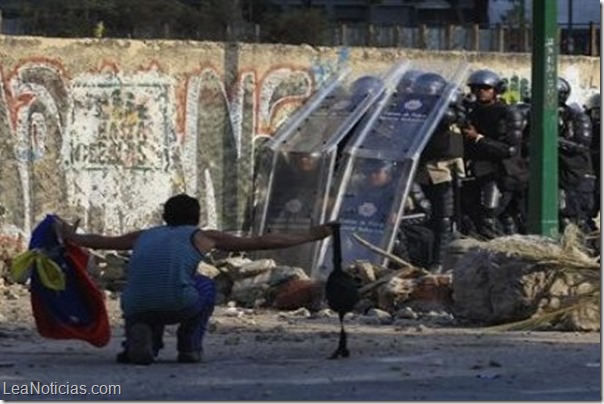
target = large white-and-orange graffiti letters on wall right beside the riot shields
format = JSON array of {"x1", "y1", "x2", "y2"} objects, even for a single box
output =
[{"x1": 179, "y1": 66, "x2": 315, "y2": 228}]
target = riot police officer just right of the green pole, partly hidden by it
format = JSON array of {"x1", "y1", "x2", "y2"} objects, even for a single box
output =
[{"x1": 557, "y1": 77, "x2": 596, "y2": 232}]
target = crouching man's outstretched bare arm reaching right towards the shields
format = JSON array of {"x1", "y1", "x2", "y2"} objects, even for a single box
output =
[{"x1": 195, "y1": 224, "x2": 332, "y2": 252}]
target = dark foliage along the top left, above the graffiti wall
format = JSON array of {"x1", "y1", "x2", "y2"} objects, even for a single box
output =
[{"x1": 2, "y1": 0, "x2": 330, "y2": 45}]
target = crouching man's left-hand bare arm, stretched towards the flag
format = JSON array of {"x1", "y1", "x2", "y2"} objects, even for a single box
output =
[{"x1": 55, "y1": 219, "x2": 141, "y2": 250}]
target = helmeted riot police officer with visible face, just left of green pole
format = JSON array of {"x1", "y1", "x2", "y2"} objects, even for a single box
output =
[{"x1": 462, "y1": 69, "x2": 528, "y2": 238}]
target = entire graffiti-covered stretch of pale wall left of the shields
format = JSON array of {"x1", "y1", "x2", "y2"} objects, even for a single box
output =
[{"x1": 0, "y1": 58, "x2": 340, "y2": 240}]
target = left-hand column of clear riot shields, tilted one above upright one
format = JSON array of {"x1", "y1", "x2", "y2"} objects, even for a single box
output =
[{"x1": 253, "y1": 63, "x2": 406, "y2": 273}]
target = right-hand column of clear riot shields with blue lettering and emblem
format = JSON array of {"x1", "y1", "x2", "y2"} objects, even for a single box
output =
[{"x1": 313, "y1": 63, "x2": 467, "y2": 278}]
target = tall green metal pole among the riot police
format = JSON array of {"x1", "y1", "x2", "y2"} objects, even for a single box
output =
[{"x1": 528, "y1": 0, "x2": 559, "y2": 238}]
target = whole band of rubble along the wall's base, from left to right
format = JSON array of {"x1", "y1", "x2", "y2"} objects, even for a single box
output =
[{"x1": 0, "y1": 224, "x2": 600, "y2": 331}]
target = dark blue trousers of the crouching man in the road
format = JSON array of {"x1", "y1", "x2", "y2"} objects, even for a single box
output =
[{"x1": 124, "y1": 275, "x2": 216, "y2": 356}]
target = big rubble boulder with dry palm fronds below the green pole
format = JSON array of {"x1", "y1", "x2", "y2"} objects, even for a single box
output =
[{"x1": 452, "y1": 226, "x2": 601, "y2": 331}]
